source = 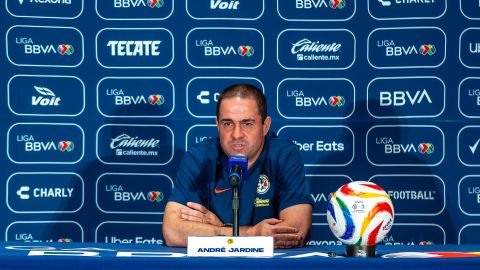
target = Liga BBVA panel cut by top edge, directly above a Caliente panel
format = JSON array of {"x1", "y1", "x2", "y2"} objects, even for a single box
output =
[{"x1": 277, "y1": 0, "x2": 356, "y2": 21}]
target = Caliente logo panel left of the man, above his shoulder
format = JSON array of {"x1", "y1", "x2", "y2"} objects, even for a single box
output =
[{"x1": 97, "y1": 124, "x2": 173, "y2": 165}]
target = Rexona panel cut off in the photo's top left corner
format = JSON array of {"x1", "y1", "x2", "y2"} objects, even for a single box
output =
[{"x1": 5, "y1": 0, "x2": 85, "y2": 19}]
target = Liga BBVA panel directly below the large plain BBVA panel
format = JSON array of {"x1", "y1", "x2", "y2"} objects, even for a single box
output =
[{"x1": 366, "y1": 125, "x2": 445, "y2": 166}]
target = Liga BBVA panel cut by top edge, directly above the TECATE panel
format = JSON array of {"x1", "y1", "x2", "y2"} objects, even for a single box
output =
[{"x1": 95, "y1": 0, "x2": 174, "y2": 20}]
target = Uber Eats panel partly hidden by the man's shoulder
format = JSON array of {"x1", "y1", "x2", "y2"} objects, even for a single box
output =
[{"x1": 278, "y1": 126, "x2": 354, "y2": 166}]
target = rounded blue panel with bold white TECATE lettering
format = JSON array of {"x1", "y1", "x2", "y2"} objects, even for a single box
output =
[{"x1": 96, "y1": 28, "x2": 173, "y2": 68}]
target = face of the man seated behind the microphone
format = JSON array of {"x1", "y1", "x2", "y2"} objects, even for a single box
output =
[{"x1": 217, "y1": 97, "x2": 271, "y2": 168}]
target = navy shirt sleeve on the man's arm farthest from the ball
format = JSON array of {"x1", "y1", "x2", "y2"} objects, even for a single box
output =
[{"x1": 169, "y1": 152, "x2": 204, "y2": 205}]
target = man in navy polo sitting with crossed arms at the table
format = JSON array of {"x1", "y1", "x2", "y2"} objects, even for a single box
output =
[{"x1": 163, "y1": 84, "x2": 312, "y2": 248}]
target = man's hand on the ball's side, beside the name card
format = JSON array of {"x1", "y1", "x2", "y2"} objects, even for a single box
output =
[{"x1": 249, "y1": 218, "x2": 302, "y2": 248}]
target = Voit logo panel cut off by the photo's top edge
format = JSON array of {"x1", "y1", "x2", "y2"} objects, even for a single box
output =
[{"x1": 186, "y1": 0, "x2": 265, "y2": 20}]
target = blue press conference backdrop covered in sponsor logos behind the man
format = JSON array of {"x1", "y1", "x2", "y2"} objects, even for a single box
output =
[{"x1": 0, "y1": 0, "x2": 480, "y2": 245}]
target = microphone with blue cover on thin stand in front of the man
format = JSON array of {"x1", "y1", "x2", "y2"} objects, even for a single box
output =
[{"x1": 228, "y1": 155, "x2": 248, "y2": 236}]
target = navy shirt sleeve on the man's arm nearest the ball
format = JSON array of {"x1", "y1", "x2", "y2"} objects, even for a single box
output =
[{"x1": 278, "y1": 145, "x2": 313, "y2": 211}]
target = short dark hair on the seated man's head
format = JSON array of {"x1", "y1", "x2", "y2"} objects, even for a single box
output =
[{"x1": 217, "y1": 83, "x2": 267, "y2": 123}]
